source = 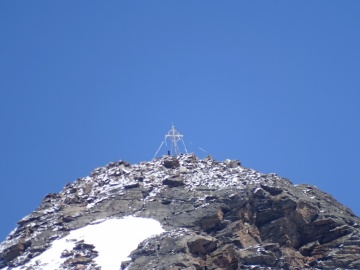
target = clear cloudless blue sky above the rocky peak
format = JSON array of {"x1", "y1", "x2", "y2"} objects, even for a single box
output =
[{"x1": 0, "y1": 0, "x2": 360, "y2": 241}]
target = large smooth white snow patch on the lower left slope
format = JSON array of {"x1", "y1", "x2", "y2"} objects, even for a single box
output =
[{"x1": 7, "y1": 216, "x2": 164, "y2": 270}]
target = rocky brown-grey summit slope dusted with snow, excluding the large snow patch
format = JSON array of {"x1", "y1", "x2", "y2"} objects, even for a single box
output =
[{"x1": 0, "y1": 154, "x2": 360, "y2": 270}]
